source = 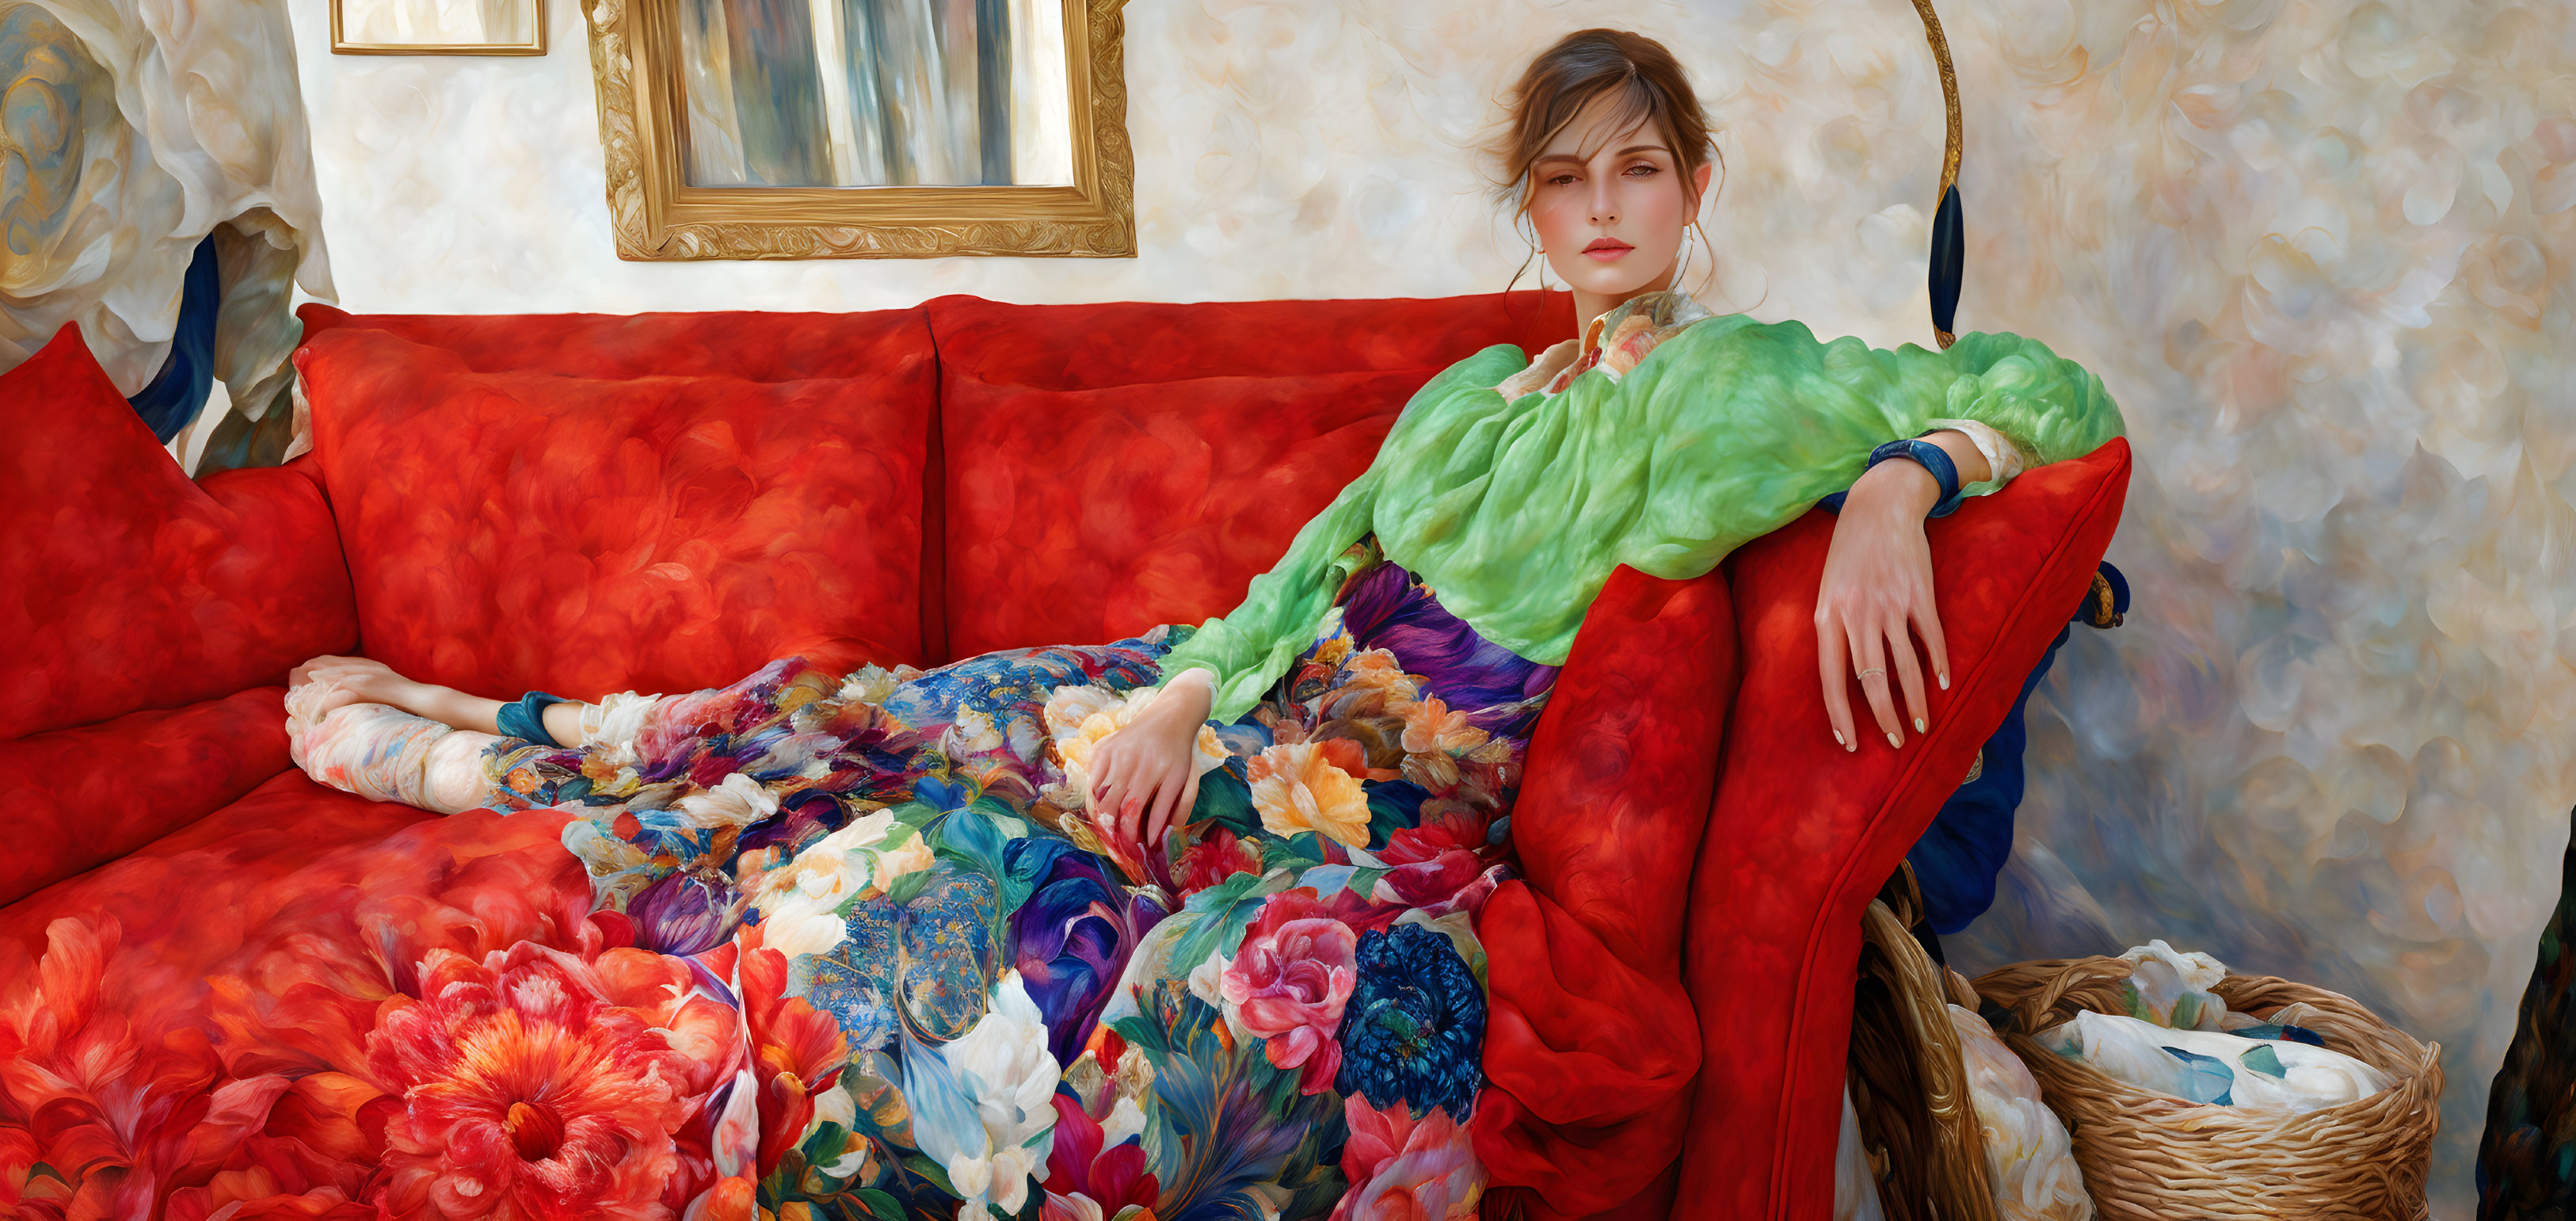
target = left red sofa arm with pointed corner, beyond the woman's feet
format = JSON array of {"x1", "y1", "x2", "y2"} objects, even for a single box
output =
[{"x1": 0, "y1": 325, "x2": 356, "y2": 736}]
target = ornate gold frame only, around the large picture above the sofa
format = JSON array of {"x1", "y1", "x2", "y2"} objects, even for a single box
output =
[{"x1": 582, "y1": 0, "x2": 1136, "y2": 260}]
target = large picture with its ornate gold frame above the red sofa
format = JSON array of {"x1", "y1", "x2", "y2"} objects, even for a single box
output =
[{"x1": 582, "y1": 0, "x2": 1136, "y2": 260}]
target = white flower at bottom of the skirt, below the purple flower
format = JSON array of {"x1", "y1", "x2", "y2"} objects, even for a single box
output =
[{"x1": 922, "y1": 971, "x2": 1061, "y2": 1219}]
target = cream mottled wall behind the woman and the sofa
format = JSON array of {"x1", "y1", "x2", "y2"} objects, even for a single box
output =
[{"x1": 294, "y1": 0, "x2": 2576, "y2": 1219}]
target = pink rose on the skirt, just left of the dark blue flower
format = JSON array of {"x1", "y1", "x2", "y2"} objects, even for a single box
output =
[{"x1": 1218, "y1": 889, "x2": 1360, "y2": 1095}]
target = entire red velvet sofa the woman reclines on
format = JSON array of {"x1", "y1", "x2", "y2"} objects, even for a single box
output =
[{"x1": 0, "y1": 294, "x2": 2128, "y2": 1219}]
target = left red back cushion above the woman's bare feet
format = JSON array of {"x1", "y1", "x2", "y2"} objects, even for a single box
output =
[{"x1": 296, "y1": 330, "x2": 932, "y2": 698}]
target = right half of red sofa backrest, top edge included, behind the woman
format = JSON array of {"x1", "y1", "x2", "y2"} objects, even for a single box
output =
[{"x1": 924, "y1": 291, "x2": 1574, "y2": 657}]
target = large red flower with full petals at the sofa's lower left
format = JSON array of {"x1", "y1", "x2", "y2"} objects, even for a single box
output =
[{"x1": 366, "y1": 943, "x2": 724, "y2": 1221}]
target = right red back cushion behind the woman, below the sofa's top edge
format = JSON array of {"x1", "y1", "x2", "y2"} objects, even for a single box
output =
[{"x1": 940, "y1": 368, "x2": 1435, "y2": 657}]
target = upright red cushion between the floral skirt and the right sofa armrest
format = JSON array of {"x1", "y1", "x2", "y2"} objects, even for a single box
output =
[{"x1": 1473, "y1": 569, "x2": 1736, "y2": 1221}]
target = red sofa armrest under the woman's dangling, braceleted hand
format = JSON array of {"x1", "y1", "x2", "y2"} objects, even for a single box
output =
[{"x1": 1675, "y1": 441, "x2": 2130, "y2": 1221}]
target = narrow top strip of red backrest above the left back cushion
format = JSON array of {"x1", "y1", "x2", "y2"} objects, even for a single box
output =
[{"x1": 296, "y1": 301, "x2": 930, "y2": 381}]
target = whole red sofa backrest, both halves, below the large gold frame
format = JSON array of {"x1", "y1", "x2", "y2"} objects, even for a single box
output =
[{"x1": 299, "y1": 291, "x2": 1574, "y2": 680}]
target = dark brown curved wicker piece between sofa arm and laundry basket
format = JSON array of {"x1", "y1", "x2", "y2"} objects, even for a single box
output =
[{"x1": 1847, "y1": 871, "x2": 1996, "y2": 1221}]
